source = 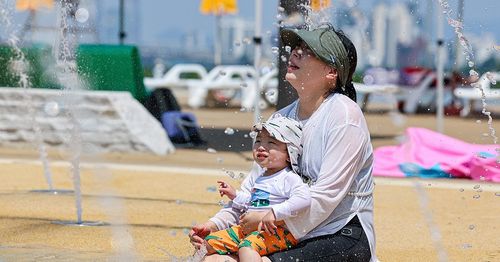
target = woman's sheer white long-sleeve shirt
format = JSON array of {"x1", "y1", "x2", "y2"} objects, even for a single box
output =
[{"x1": 209, "y1": 94, "x2": 376, "y2": 261}]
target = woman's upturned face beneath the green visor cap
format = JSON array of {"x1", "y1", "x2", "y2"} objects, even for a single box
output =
[{"x1": 285, "y1": 42, "x2": 336, "y2": 94}]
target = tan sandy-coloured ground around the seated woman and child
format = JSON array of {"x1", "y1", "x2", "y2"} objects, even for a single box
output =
[{"x1": 0, "y1": 105, "x2": 500, "y2": 261}]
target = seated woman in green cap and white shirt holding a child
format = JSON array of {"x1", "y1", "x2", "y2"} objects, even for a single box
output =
[{"x1": 190, "y1": 26, "x2": 376, "y2": 261}]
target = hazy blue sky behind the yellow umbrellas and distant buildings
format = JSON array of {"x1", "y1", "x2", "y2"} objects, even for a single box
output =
[{"x1": 0, "y1": 0, "x2": 500, "y2": 49}]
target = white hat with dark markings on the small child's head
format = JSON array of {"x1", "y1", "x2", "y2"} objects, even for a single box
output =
[{"x1": 252, "y1": 115, "x2": 302, "y2": 174}]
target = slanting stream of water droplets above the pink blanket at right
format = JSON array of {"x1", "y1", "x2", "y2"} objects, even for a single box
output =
[{"x1": 438, "y1": 0, "x2": 500, "y2": 146}]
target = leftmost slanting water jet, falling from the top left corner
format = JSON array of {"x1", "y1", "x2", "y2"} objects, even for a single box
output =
[{"x1": 0, "y1": 1, "x2": 57, "y2": 189}]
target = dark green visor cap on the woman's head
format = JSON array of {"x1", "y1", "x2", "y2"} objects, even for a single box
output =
[{"x1": 281, "y1": 26, "x2": 350, "y2": 88}]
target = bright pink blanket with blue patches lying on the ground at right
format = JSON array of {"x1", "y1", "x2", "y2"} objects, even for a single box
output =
[{"x1": 373, "y1": 127, "x2": 500, "y2": 182}]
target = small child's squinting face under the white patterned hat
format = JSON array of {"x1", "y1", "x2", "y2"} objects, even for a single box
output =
[{"x1": 253, "y1": 129, "x2": 289, "y2": 175}]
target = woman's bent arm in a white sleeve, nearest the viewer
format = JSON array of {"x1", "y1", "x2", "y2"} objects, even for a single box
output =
[{"x1": 285, "y1": 124, "x2": 370, "y2": 238}]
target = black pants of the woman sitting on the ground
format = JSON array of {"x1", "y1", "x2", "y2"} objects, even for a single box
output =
[{"x1": 268, "y1": 216, "x2": 371, "y2": 262}]
